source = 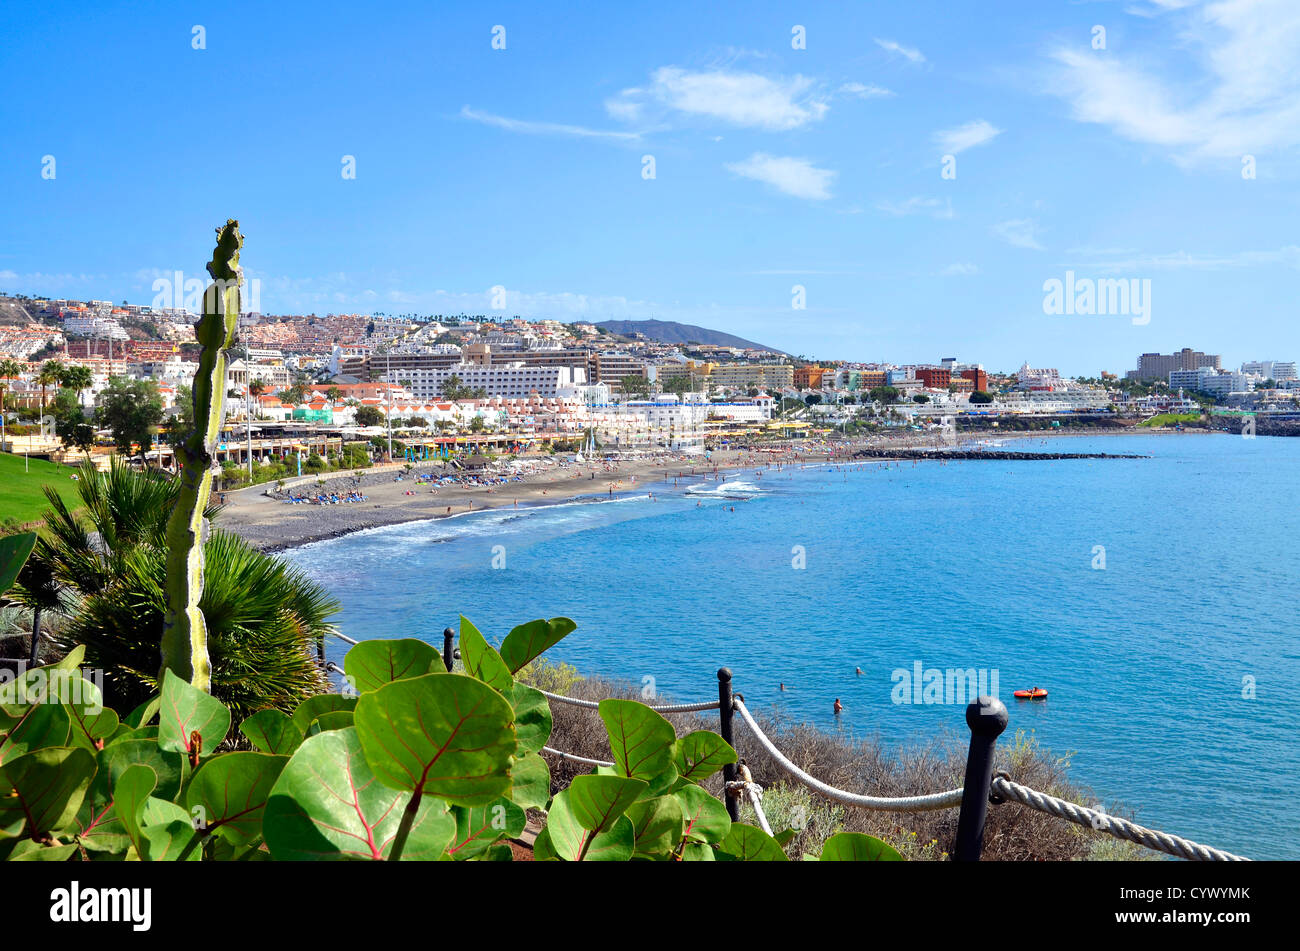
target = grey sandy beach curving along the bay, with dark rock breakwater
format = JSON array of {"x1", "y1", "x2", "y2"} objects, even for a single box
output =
[{"x1": 217, "y1": 430, "x2": 1212, "y2": 553}]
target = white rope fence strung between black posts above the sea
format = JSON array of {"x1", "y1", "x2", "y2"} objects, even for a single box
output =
[{"x1": 320, "y1": 628, "x2": 1249, "y2": 861}]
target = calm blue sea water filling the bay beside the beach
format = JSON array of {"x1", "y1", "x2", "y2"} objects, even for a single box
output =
[{"x1": 286, "y1": 435, "x2": 1300, "y2": 859}]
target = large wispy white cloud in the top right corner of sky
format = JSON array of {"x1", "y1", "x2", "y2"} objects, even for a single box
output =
[{"x1": 1047, "y1": 0, "x2": 1300, "y2": 161}]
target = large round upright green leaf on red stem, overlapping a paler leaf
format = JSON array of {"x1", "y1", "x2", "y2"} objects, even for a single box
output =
[{"x1": 356, "y1": 673, "x2": 516, "y2": 805}]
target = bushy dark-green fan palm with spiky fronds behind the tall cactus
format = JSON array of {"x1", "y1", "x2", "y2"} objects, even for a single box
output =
[{"x1": 40, "y1": 459, "x2": 338, "y2": 735}]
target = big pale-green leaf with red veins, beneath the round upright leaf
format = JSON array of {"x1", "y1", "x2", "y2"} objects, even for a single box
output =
[{"x1": 263, "y1": 729, "x2": 456, "y2": 861}]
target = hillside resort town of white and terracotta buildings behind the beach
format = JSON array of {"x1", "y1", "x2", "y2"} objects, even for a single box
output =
[{"x1": 0, "y1": 285, "x2": 1300, "y2": 473}]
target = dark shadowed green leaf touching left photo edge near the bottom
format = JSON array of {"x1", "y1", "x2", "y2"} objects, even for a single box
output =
[{"x1": 0, "y1": 746, "x2": 95, "y2": 837}]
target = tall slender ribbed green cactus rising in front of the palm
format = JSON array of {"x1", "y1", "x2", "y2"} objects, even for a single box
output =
[{"x1": 159, "y1": 218, "x2": 243, "y2": 692}]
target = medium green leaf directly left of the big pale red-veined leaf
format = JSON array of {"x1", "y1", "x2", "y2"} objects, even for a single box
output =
[{"x1": 185, "y1": 752, "x2": 289, "y2": 846}]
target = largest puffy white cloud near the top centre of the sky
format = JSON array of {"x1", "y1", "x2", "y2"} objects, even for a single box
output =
[{"x1": 605, "y1": 66, "x2": 829, "y2": 131}]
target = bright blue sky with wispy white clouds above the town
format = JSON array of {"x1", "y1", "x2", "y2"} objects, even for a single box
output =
[{"x1": 0, "y1": 0, "x2": 1300, "y2": 375}]
